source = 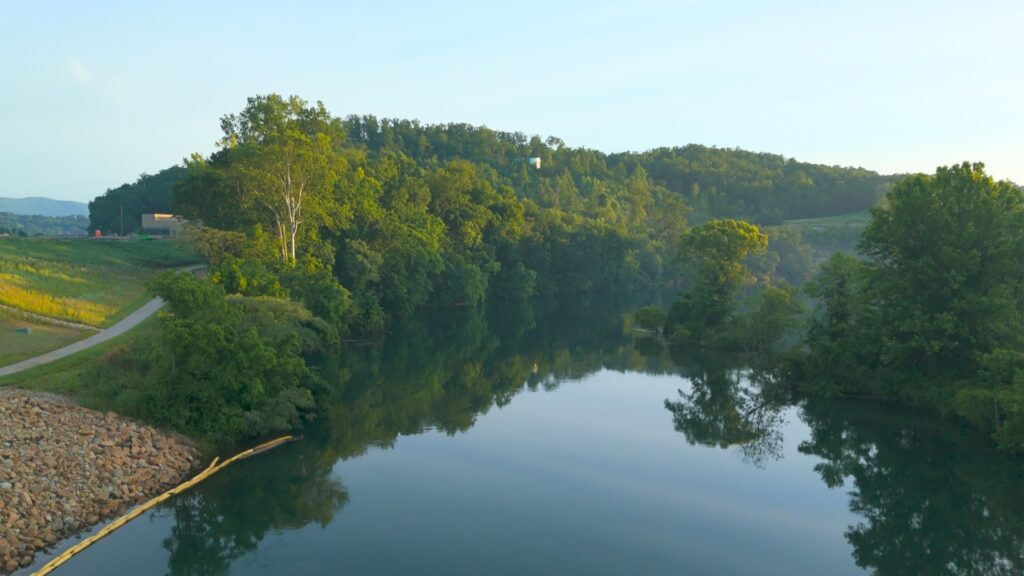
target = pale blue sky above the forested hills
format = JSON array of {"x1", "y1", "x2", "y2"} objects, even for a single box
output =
[{"x1": 0, "y1": 0, "x2": 1024, "y2": 201}]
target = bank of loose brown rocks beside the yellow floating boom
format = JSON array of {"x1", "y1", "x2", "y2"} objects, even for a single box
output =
[{"x1": 0, "y1": 389, "x2": 198, "y2": 574}]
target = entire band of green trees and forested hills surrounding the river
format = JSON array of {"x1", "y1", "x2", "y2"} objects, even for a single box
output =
[{"x1": 81, "y1": 95, "x2": 1024, "y2": 450}]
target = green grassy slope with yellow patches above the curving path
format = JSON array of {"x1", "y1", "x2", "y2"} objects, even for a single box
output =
[{"x1": 0, "y1": 238, "x2": 199, "y2": 327}]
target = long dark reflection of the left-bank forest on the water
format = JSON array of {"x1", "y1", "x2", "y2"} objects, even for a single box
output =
[{"x1": 151, "y1": 293, "x2": 648, "y2": 575}]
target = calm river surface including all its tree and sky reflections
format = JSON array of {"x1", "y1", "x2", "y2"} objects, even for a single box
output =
[{"x1": 19, "y1": 302, "x2": 1024, "y2": 576}]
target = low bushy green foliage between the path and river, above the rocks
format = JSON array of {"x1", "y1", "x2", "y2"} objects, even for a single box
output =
[{"x1": 83, "y1": 273, "x2": 330, "y2": 444}]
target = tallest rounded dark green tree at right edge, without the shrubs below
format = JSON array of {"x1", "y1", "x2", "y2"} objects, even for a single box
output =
[{"x1": 860, "y1": 162, "x2": 1024, "y2": 377}]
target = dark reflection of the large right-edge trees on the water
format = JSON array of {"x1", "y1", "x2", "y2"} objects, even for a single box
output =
[{"x1": 800, "y1": 402, "x2": 1024, "y2": 576}]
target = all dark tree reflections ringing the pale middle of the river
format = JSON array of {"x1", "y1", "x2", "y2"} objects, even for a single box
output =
[{"x1": 148, "y1": 300, "x2": 1024, "y2": 575}]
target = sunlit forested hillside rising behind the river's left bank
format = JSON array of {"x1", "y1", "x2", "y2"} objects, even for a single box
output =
[{"x1": 163, "y1": 94, "x2": 888, "y2": 332}]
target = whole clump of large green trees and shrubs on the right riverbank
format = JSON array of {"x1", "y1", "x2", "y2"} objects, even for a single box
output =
[{"x1": 802, "y1": 163, "x2": 1024, "y2": 450}]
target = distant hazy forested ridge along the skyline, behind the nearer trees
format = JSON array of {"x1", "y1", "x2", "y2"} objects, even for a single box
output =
[{"x1": 342, "y1": 116, "x2": 898, "y2": 224}]
